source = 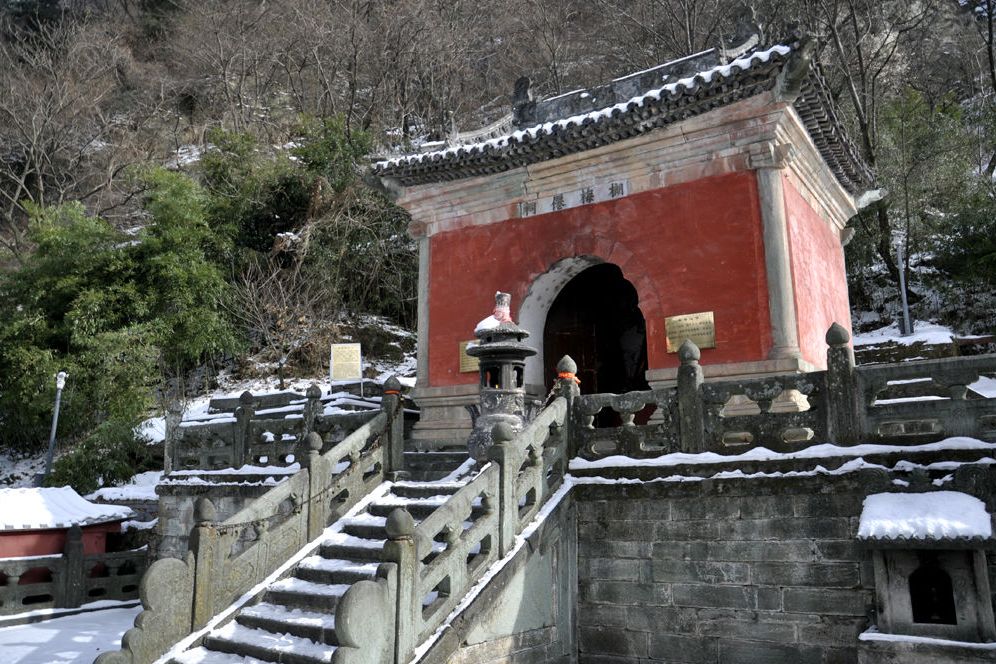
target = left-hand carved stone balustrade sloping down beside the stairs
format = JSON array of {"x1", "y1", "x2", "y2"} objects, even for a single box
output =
[{"x1": 96, "y1": 379, "x2": 404, "y2": 664}]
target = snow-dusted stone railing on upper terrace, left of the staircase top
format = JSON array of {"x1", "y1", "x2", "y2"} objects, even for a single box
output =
[{"x1": 164, "y1": 385, "x2": 377, "y2": 472}]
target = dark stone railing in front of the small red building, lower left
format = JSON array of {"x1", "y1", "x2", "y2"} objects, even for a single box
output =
[{"x1": 0, "y1": 526, "x2": 148, "y2": 615}]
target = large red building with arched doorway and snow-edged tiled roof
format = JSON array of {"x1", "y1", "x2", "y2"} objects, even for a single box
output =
[{"x1": 374, "y1": 39, "x2": 872, "y2": 447}]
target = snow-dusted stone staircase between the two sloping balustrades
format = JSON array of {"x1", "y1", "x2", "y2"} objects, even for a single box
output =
[{"x1": 170, "y1": 476, "x2": 482, "y2": 664}]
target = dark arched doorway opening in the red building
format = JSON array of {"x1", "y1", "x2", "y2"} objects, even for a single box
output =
[{"x1": 543, "y1": 263, "x2": 649, "y2": 394}]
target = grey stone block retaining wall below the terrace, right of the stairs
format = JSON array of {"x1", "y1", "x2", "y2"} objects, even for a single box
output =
[{"x1": 575, "y1": 471, "x2": 996, "y2": 664}]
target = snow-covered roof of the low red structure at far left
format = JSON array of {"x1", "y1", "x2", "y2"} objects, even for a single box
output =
[{"x1": 0, "y1": 486, "x2": 135, "y2": 532}]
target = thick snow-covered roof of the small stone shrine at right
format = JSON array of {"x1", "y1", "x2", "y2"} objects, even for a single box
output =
[{"x1": 858, "y1": 491, "x2": 993, "y2": 542}]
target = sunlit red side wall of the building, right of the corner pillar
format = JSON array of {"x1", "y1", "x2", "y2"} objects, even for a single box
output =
[{"x1": 783, "y1": 178, "x2": 851, "y2": 368}]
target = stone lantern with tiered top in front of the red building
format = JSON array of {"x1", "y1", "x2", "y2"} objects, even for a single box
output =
[{"x1": 467, "y1": 292, "x2": 536, "y2": 462}]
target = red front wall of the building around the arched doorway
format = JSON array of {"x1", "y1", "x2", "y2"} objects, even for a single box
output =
[{"x1": 429, "y1": 172, "x2": 771, "y2": 386}]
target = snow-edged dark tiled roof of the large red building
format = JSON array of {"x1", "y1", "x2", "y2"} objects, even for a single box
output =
[{"x1": 373, "y1": 42, "x2": 873, "y2": 193}]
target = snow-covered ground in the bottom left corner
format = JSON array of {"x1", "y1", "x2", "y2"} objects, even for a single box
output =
[{"x1": 0, "y1": 606, "x2": 142, "y2": 664}]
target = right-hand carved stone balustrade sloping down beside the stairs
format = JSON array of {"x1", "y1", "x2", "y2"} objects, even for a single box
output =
[{"x1": 382, "y1": 380, "x2": 577, "y2": 662}]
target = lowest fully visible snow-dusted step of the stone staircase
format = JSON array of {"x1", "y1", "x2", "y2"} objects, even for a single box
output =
[{"x1": 204, "y1": 622, "x2": 335, "y2": 664}]
